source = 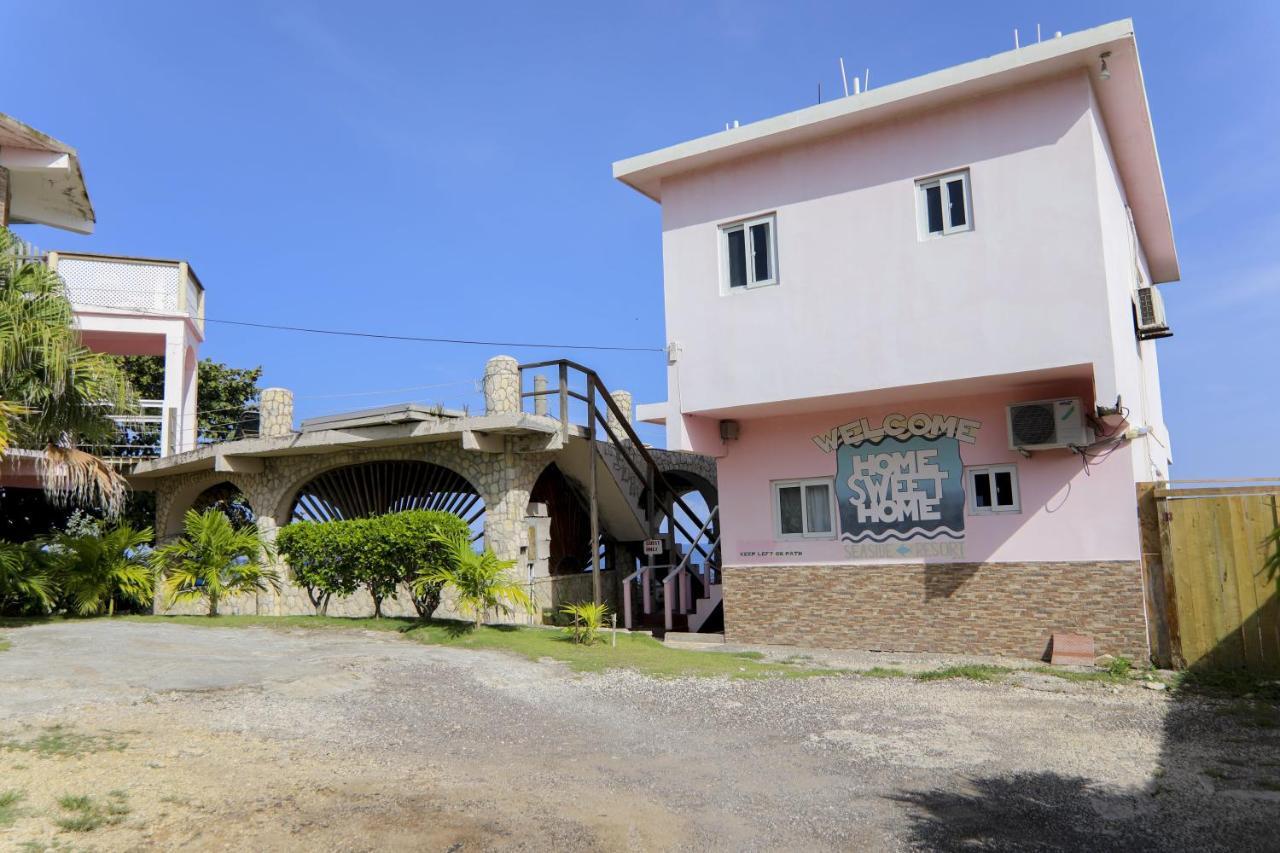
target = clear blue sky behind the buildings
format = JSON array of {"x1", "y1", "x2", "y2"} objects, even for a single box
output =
[{"x1": 0, "y1": 0, "x2": 1280, "y2": 478}]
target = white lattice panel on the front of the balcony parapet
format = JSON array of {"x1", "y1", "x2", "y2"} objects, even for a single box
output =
[{"x1": 58, "y1": 257, "x2": 182, "y2": 314}]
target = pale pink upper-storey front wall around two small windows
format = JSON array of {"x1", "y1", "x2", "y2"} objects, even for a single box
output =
[{"x1": 663, "y1": 73, "x2": 1116, "y2": 438}]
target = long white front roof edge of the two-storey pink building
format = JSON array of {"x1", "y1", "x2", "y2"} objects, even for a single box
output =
[{"x1": 613, "y1": 18, "x2": 1134, "y2": 188}]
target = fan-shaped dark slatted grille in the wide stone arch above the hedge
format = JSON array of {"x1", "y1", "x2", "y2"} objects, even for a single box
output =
[{"x1": 289, "y1": 461, "x2": 485, "y2": 530}]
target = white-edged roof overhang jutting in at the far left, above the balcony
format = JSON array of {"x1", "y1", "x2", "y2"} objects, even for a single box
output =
[{"x1": 0, "y1": 113, "x2": 97, "y2": 234}]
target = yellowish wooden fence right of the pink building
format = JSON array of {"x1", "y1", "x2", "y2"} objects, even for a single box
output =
[{"x1": 1138, "y1": 479, "x2": 1280, "y2": 672}]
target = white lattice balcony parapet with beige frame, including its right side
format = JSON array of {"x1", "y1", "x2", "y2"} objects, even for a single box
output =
[{"x1": 47, "y1": 252, "x2": 205, "y2": 327}]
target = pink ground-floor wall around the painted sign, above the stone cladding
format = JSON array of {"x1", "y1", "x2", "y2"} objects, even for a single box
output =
[{"x1": 719, "y1": 383, "x2": 1139, "y2": 566}]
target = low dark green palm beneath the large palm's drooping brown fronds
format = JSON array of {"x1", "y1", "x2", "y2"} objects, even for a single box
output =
[{"x1": 50, "y1": 524, "x2": 155, "y2": 616}]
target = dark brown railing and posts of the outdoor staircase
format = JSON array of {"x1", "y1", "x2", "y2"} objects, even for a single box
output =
[{"x1": 520, "y1": 359, "x2": 719, "y2": 614}]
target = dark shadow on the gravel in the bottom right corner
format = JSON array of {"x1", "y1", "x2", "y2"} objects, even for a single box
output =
[{"x1": 891, "y1": 655, "x2": 1280, "y2": 852}]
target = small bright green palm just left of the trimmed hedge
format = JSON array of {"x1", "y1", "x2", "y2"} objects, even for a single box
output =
[{"x1": 152, "y1": 510, "x2": 280, "y2": 616}]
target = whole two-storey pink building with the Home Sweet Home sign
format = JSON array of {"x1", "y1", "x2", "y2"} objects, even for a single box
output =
[{"x1": 614, "y1": 20, "x2": 1179, "y2": 656}]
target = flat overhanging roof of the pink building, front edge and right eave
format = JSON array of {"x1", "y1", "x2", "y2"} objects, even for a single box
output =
[{"x1": 613, "y1": 18, "x2": 1180, "y2": 283}]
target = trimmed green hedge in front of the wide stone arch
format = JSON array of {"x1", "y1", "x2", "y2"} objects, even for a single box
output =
[{"x1": 275, "y1": 510, "x2": 470, "y2": 619}]
